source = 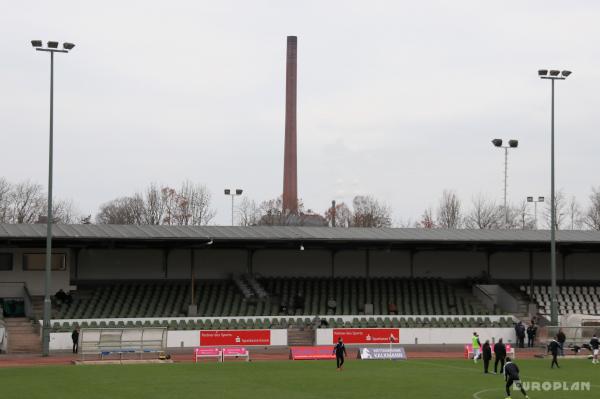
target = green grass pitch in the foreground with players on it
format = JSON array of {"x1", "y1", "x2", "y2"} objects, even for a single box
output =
[{"x1": 0, "y1": 359, "x2": 600, "y2": 399}]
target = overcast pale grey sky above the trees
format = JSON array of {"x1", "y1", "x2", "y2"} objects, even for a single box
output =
[{"x1": 0, "y1": 0, "x2": 600, "y2": 224}]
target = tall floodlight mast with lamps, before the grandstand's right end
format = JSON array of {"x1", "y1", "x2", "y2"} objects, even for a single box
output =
[{"x1": 538, "y1": 69, "x2": 571, "y2": 326}]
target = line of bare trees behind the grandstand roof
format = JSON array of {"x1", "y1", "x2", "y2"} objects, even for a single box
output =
[{"x1": 0, "y1": 177, "x2": 600, "y2": 230}]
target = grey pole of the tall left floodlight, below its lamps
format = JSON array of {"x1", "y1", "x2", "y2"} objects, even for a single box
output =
[{"x1": 42, "y1": 52, "x2": 54, "y2": 356}]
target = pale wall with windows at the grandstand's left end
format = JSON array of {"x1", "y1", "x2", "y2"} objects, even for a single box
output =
[{"x1": 0, "y1": 248, "x2": 72, "y2": 297}]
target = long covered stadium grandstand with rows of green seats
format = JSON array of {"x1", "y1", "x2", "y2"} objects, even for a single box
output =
[{"x1": 0, "y1": 224, "x2": 600, "y2": 352}]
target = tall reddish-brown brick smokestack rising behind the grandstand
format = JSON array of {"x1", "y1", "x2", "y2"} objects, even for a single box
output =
[{"x1": 283, "y1": 36, "x2": 298, "y2": 214}]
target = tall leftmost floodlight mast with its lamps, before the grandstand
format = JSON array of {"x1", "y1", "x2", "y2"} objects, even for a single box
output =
[{"x1": 31, "y1": 40, "x2": 75, "y2": 356}]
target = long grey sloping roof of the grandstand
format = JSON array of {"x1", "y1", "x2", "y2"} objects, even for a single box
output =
[{"x1": 0, "y1": 224, "x2": 600, "y2": 250}]
